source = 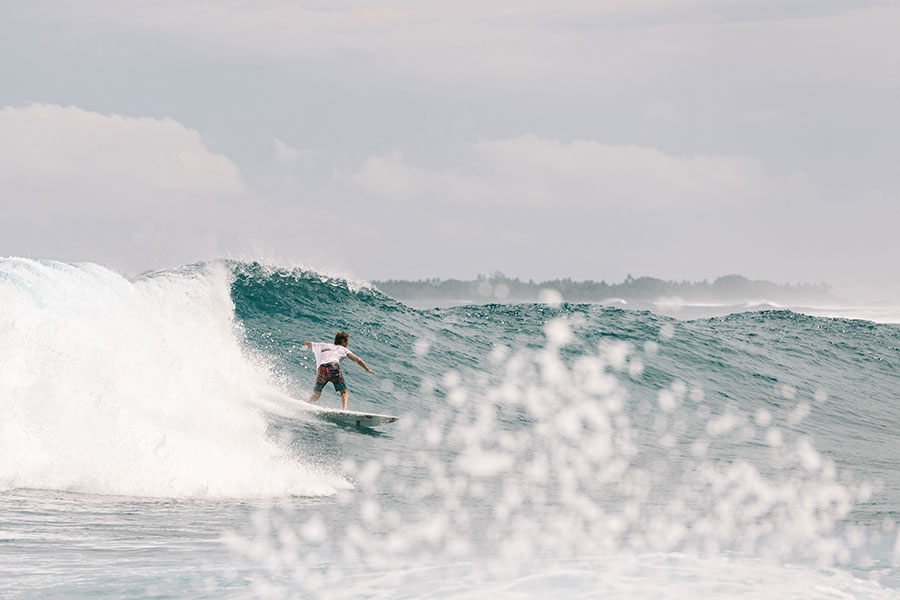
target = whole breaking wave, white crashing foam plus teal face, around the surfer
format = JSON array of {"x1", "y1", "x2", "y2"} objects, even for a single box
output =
[{"x1": 0, "y1": 259, "x2": 900, "y2": 510}]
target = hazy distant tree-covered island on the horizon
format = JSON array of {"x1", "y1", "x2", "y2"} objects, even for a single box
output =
[{"x1": 372, "y1": 272, "x2": 840, "y2": 305}]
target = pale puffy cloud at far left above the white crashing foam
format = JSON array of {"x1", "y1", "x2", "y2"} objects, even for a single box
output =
[{"x1": 0, "y1": 104, "x2": 245, "y2": 213}]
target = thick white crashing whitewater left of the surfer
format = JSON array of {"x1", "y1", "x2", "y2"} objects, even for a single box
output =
[{"x1": 0, "y1": 259, "x2": 349, "y2": 497}]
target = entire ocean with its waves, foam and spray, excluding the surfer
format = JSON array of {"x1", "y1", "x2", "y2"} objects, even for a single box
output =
[{"x1": 0, "y1": 258, "x2": 900, "y2": 599}]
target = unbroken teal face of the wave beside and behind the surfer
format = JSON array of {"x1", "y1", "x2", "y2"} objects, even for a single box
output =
[{"x1": 232, "y1": 264, "x2": 900, "y2": 490}]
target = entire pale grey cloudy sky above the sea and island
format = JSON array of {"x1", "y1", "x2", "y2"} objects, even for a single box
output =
[{"x1": 0, "y1": 0, "x2": 900, "y2": 301}]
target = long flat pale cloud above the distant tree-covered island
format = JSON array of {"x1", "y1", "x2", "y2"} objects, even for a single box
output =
[{"x1": 350, "y1": 135, "x2": 803, "y2": 208}]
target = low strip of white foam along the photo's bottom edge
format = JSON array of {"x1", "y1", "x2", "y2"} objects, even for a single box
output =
[{"x1": 221, "y1": 552, "x2": 897, "y2": 600}]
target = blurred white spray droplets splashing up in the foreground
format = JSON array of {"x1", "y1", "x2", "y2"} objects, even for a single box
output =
[{"x1": 228, "y1": 315, "x2": 877, "y2": 595}]
